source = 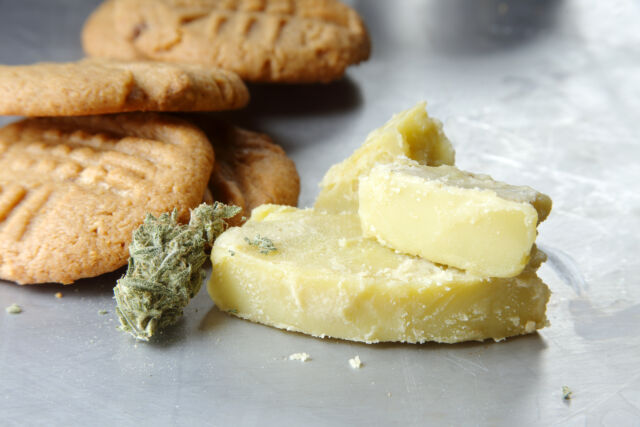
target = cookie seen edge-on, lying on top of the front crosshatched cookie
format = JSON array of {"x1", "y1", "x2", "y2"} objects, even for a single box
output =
[{"x1": 0, "y1": 59, "x2": 249, "y2": 116}]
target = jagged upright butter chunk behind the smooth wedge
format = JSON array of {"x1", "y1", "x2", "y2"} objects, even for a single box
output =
[{"x1": 315, "y1": 102, "x2": 455, "y2": 213}]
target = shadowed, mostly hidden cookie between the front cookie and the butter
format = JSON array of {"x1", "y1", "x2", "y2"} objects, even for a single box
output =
[{"x1": 197, "y1": 120, "x2": 300, "y2": 225}]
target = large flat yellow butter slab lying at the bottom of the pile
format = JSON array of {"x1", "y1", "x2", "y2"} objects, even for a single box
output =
[{"x1": 208, "y1": 205, "x2": 549, "y2": 343}]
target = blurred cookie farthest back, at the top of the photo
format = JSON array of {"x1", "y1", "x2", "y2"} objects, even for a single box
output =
[{"x1": 83, "y1": 0, "x2": 370, "y2": 83}]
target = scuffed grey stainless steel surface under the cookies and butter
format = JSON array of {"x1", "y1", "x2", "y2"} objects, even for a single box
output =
[{"x1": 0, "y1": 0, "x2": 640, "y2": 426}]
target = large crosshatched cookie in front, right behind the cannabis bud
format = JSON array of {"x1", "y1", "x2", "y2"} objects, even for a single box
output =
[{"x1": 0, "y1": 113, "x2": 214, "y2": 284}]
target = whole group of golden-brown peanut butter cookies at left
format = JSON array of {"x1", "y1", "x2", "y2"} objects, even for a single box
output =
[{"x1": 0, "y1": 0, "x2": 369, "y2": 284}]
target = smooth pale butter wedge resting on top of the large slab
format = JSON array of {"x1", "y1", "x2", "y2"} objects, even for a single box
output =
[{"x1": 359, "y1": 164, "x2": 551, "y2": 277}]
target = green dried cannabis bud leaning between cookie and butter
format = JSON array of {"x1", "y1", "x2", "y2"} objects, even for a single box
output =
[{"x1": 113, "y1": 202, "x2": 241, "y2": 341}]
